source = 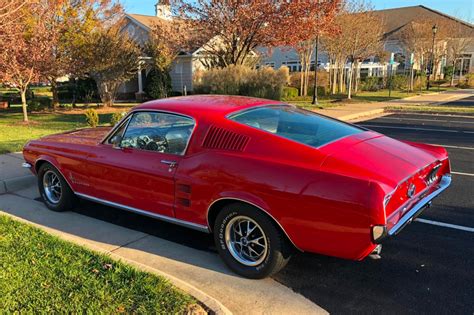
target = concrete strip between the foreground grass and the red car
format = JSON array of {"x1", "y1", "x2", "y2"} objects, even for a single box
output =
[{"x1": 0, "y1": 178, "x2": 327, "y2": 314}]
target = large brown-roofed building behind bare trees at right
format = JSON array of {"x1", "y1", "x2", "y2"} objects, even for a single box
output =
[{"x1": 261, "y1": 5, "x2": 474, "y2": 76}]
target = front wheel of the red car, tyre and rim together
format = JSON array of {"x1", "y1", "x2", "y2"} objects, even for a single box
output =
[{"x1": 38, "y1": 163, "x2": 75, "y2": 212}]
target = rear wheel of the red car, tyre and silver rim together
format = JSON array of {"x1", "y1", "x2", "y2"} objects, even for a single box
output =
[{"x1": 214, "y1": 203, "x2": 292, "y2": 279}]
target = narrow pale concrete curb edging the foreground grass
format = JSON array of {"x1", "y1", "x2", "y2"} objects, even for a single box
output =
[{"x1": 0, "y1": 210, "x2": 233, "y2": 315}]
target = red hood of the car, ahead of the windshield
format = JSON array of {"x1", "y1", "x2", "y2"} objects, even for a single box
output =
[{"x1": 40, "y1": 127, "x2": 111, "y2": 145}]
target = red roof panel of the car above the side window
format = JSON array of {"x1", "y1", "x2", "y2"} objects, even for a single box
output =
[{"x1": 134, "y1": 95, "x2": 285, "y2": 119}]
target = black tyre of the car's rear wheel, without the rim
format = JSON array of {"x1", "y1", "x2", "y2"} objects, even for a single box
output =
[{"x1": 214, "y1": 203, "x2": 293, "y2": 279}]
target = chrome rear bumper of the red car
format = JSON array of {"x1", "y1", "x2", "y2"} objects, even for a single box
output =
[{"x1": 373, "y1": 174, "x2": 451, "y2": 244}]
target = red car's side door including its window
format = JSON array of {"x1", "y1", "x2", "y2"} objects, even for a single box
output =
[{"x1": 88, "y1": 111, "x2": 194, "y2": 217}]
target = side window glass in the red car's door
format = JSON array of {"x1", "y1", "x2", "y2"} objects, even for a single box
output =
[{"x1": 121, "y1": 112, "x2": 194, "y2": 155}]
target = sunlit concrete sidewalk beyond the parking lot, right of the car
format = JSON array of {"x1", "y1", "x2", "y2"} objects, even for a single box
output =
[{"x1": 315, "y1": 89, "x2": 474, "y2": 121}]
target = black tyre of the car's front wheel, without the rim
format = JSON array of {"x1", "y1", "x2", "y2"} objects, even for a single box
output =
[{"x1": 38, "y1": 163, "x2": 76, "y2": 212}]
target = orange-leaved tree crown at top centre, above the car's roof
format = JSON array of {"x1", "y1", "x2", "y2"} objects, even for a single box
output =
[{"x1": 178, "y1": 0, "x2": 340, "y2": 67}]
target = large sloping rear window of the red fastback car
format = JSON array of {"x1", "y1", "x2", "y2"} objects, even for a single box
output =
[{"x1": 229, "y1": 105, "x2": 364, "y2": 147}]
